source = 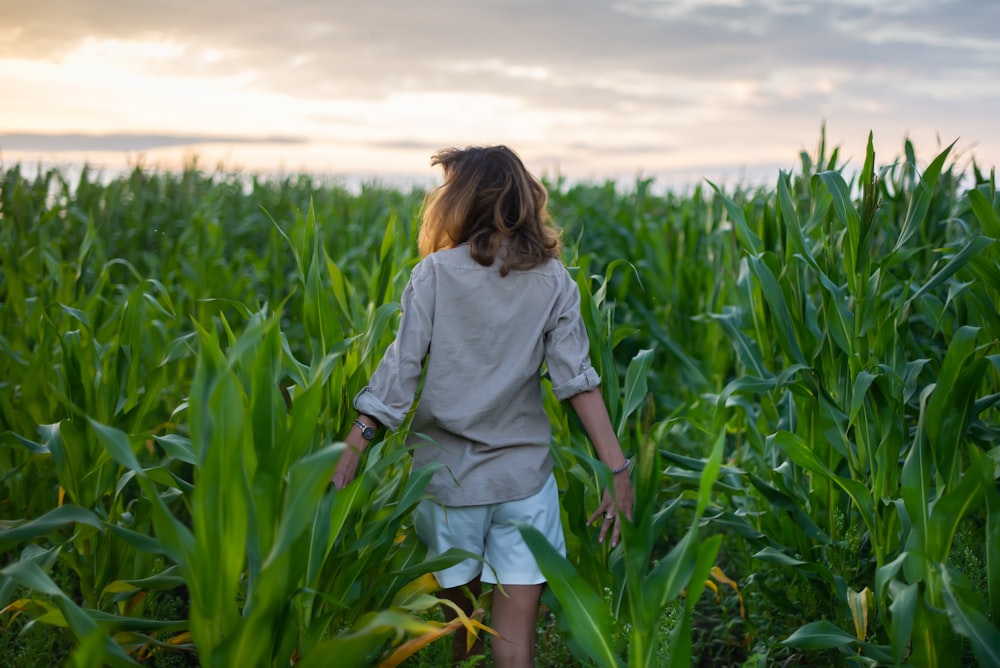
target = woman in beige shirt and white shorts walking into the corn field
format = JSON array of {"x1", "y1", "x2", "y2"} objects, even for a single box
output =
[{"x1": 333, "y1": 146, "x2": 633, "y2": 667}]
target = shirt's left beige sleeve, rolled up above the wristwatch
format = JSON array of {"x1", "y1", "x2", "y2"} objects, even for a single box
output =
[{"x1": 353, "y1": 264, "x2": 434, "y2": 430}]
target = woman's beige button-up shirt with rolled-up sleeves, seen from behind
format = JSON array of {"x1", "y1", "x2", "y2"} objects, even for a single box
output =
[{"x1": 354, "y1": 245, "x2": 600, "y2": 506}]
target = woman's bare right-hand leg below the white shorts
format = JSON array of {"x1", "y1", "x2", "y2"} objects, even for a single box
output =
[{"x1": 491, "y1": 584, "x2": 545, "y2": 668}]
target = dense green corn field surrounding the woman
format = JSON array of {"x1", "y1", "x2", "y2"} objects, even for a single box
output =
[{"x1": 0, "y1": 133, "x2": 1000, "y2": 668}]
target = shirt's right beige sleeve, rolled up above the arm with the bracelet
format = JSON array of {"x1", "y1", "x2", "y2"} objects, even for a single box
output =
[{"x1": 545, "y1": 275, "x2": 601, "y2": 401}]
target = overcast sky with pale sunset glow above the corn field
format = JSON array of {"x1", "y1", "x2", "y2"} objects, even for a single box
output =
[{"x1": 0, "y1": 0, "x2": 1000, "y2": 187}]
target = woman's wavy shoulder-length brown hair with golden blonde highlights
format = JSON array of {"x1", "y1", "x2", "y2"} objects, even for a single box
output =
[{"x1": 418, "y1": 146, "x2": 562, "y2": 276}]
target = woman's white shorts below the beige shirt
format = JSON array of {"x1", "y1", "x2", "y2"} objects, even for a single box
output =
[{"x1": 414, "y1": 475, "x2": 566, "y2": 588}]
